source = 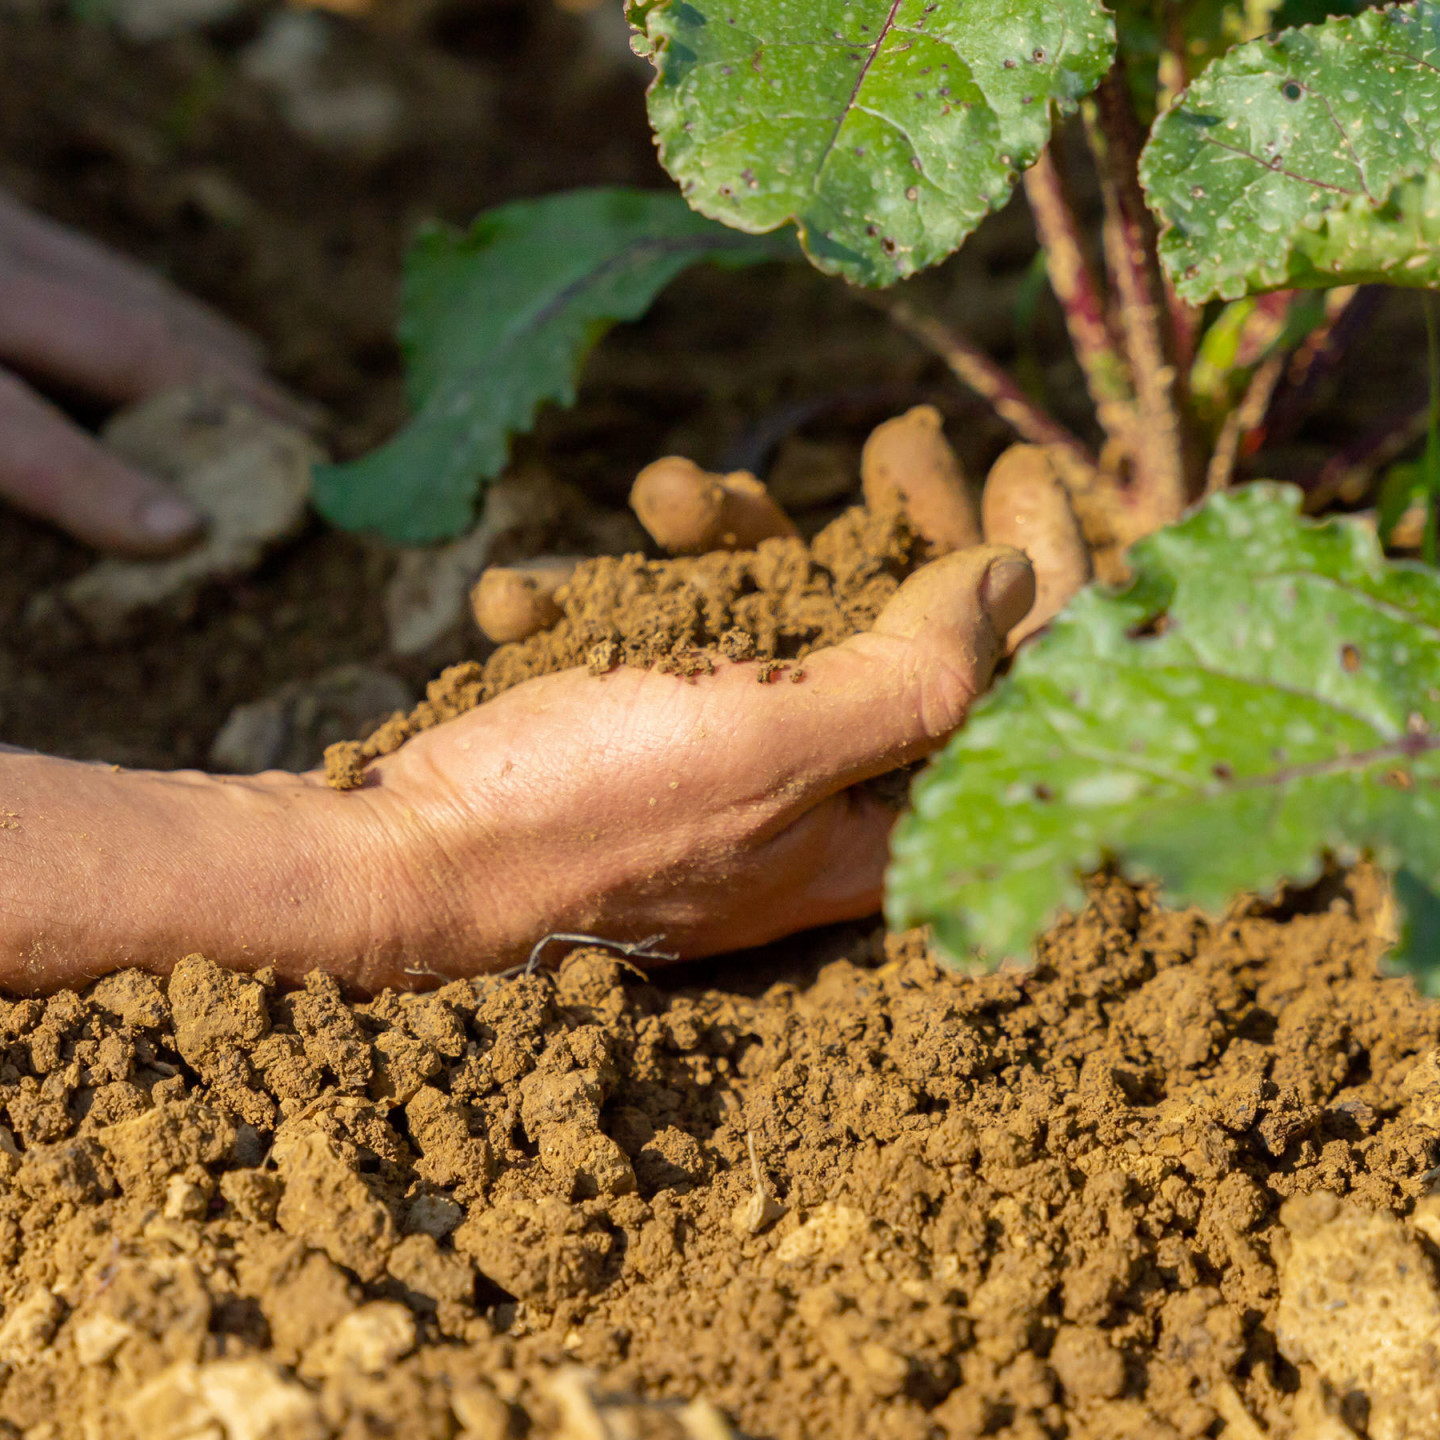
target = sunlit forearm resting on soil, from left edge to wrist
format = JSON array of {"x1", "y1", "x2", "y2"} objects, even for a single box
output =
[{"x1": 0, "y1": 747, "x2": 420, "y2": 991}]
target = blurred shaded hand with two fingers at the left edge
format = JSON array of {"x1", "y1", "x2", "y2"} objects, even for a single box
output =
[{"x1": 0, "y1": 192, "x2": 306, "y2": 554}]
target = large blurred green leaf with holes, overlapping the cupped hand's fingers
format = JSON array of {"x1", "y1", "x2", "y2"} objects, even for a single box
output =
[{"x1": 886, "y1": 485, "x2": 1440, "y2": 989}]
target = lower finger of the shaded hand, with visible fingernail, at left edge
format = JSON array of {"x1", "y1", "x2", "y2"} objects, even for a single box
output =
[{"x1": 0, "y1": 372, "x2": 204, "y2": 556}]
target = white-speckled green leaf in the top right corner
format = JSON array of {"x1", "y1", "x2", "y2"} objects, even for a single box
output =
[{"x1": 1140, "y1": 0, "x2": 1440, "y2": 302}]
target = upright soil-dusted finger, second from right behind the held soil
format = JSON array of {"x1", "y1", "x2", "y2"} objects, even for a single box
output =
[{"x1": 860, "y1": 405, "x2": 981, "y2": 553}]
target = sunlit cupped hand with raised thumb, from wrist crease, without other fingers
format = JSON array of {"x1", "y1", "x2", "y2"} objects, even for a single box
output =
[{"x1": 346, "y1": 546, "x2": 1035, "y2": 988}]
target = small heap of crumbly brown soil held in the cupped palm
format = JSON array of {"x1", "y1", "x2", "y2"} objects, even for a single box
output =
[{"x1": 325, "y1": 501, "x2": 930, "y2": 791}]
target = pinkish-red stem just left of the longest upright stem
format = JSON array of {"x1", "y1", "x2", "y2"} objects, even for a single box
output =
[{"x1": 1025, "y1": 145, "x2": 1135, "y2": 451}]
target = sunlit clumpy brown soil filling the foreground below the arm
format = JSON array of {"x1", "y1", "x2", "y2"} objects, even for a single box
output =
[{"x1": 0, "y1": 874, "x2": 1440, "y2": 1440}]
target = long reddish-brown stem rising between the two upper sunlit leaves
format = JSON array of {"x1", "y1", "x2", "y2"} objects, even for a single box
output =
[{"x1": 1086, "y1": 68, "x2": 1200, "y2": 528}]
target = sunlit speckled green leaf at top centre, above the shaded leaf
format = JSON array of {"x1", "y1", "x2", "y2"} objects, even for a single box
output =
[{"x1": 628, "y1": 0, "x2": 1115, "y2": 285}]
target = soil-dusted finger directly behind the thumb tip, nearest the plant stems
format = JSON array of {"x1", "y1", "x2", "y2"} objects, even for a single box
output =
[{"x1": 981, "y1": 445, "x2": 1093, "y2": 649}]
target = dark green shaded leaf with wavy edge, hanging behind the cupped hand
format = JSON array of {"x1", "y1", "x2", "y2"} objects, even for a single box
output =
[{"x1": 315, "y1": 189, "x2": 795, "y2": 544}]
